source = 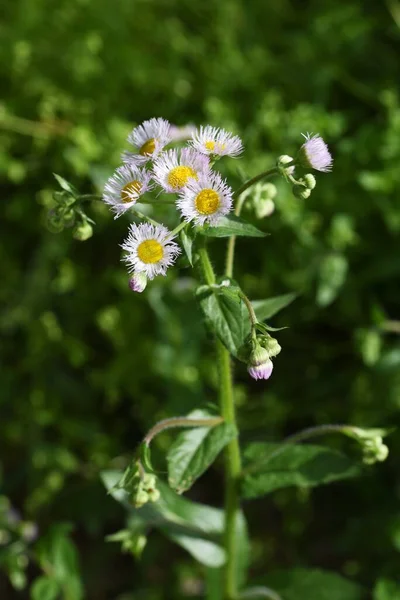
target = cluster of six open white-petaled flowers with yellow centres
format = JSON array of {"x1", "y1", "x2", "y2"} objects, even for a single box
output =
[{"x1": 103, "y1": 118, "x2": 243, "y2": 292}]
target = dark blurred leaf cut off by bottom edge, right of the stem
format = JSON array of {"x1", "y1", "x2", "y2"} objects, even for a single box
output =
[{"x1": 262, "y1": 569, "x2": 364, "y2": 600}]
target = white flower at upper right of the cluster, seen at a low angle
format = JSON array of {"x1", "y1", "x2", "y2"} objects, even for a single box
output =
[{"x1": 190, "y1": 125, "x2": 243, "y2": 157}]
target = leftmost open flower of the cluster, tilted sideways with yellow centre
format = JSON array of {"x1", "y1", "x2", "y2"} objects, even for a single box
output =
[{"x1": 103, "y1": 164, "x2": 152, "y2": 218}]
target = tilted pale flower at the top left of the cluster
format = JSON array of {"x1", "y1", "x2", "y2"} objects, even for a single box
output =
[{"x1": 124, "y1": 118, "x2": 171, "y2": 165}]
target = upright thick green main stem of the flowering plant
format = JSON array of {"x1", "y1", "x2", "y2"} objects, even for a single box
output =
[{"x1": 199, "y1": 240, "x2": 242, "y2": 600}]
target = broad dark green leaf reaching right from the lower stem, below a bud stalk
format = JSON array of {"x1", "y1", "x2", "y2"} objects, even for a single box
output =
[{"x1": 242, "y1": 443, "x2": 360, "y2": 498}]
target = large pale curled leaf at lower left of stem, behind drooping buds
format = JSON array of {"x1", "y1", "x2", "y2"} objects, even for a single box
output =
[{"x1": 101, "y1": 471, "x2": 249, "y2": 582}]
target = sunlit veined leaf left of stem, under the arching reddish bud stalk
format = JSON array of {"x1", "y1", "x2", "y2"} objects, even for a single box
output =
[{"x1": 167, "y1": 410, "x2": 237, "y2": 494}]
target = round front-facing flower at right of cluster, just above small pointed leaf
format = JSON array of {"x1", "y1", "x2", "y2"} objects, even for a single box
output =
[{"x1": 177, "y1": 171, "x2": 232, "y2": 225}]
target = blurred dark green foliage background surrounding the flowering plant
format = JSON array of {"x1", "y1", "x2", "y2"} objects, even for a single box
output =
[{"x1": 0, "y1": 0, "x2": 400, "y2": 600}]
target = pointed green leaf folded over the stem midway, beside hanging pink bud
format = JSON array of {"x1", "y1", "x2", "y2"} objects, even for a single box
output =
[{"x1": 197, "y1": 285, "x2": 249, "y2": 356}]
